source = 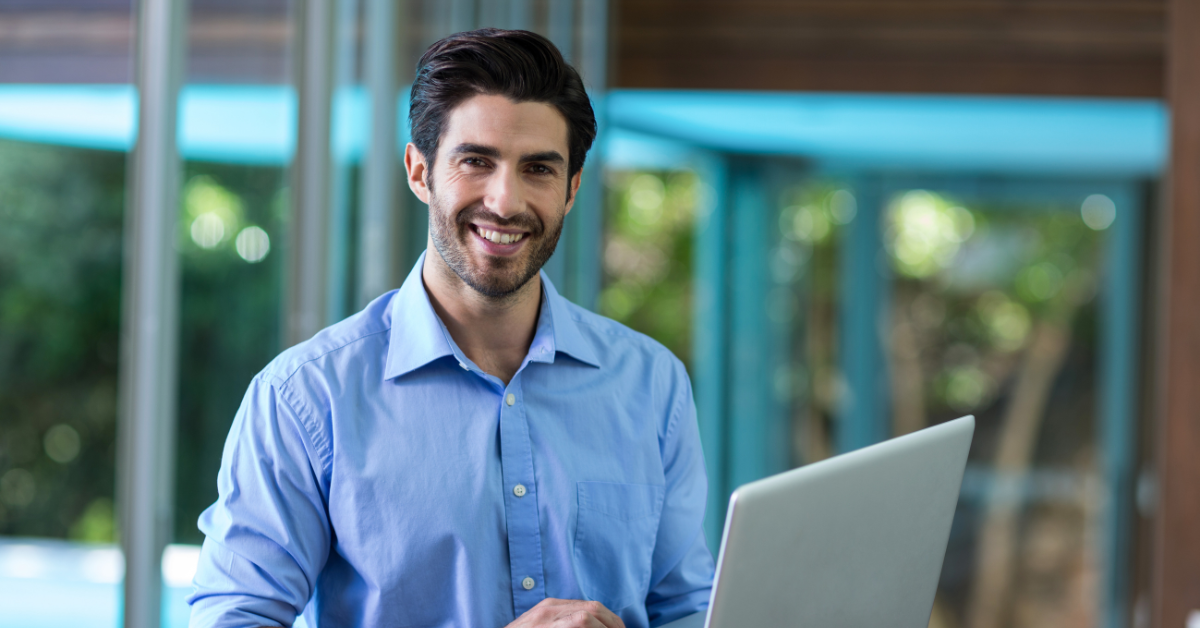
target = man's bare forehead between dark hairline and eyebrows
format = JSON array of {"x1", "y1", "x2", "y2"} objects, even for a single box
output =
[{"x1": 439, "y1": 94, "x2": 568, "y2": 157}]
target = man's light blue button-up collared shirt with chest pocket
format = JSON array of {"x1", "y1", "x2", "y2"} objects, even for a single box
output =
[{"x1": 188, "y1": 256, "x2": 713, "y2": 628}]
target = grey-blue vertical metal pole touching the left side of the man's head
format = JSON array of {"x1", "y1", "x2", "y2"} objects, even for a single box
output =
[{"x1": 355, "y1": 0, "x2": 408, "y2": 307}]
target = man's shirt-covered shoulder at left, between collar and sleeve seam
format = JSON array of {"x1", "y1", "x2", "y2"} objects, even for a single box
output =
[{"x1": 259, "y1": 291, "x2": 396, "y2": 385}]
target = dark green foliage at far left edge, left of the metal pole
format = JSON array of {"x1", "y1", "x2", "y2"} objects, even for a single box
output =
[{"x1": 0, "y1": 142, "x2": 125, "y2": 537}]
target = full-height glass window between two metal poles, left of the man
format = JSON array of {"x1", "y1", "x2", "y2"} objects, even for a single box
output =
[{"x1": 163, "y1": 0, "x2": 295, "y2": 626}]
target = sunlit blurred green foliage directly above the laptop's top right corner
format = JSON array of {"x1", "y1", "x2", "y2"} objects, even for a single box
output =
[{"x1": 886, "y1": 190, "x2": 1111, "y2": 418}]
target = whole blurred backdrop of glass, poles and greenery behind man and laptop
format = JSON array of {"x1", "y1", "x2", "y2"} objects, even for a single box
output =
[{"x1": 0, "y1": 0, "x2": 1200, "y2": 628}]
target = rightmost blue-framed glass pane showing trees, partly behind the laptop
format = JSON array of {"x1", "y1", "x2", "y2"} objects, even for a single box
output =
[{"x1": 884, "y1": 190, "x2": 1111, "y2": 628}]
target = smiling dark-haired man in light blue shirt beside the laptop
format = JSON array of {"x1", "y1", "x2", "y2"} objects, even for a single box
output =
[{"x1": 190, "y1": 29, "x2": 713, "y2": 628}]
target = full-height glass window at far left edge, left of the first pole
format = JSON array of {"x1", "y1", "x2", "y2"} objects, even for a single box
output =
[{"x1": 0, "y1": 0, "x2": 133, "y2": 626}]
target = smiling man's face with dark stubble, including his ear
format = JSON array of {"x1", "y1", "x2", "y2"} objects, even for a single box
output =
[{"x1": 404, "y1": 95, "x2": 578, "y2": 297}]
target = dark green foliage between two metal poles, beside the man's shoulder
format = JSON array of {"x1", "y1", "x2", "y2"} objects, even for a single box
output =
[{"x1": 175, "y1": 162, "x2": 287, "y2": 543}]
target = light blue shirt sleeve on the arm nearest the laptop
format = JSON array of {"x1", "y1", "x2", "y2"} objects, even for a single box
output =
[{"x1": 646, "y1": 360, "x2": 713, "y2": 626}]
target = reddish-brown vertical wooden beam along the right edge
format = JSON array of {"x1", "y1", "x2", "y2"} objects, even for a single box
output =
[{"x1": 1153, "y1": 0, "x2": 1200, "y2": 628}]
